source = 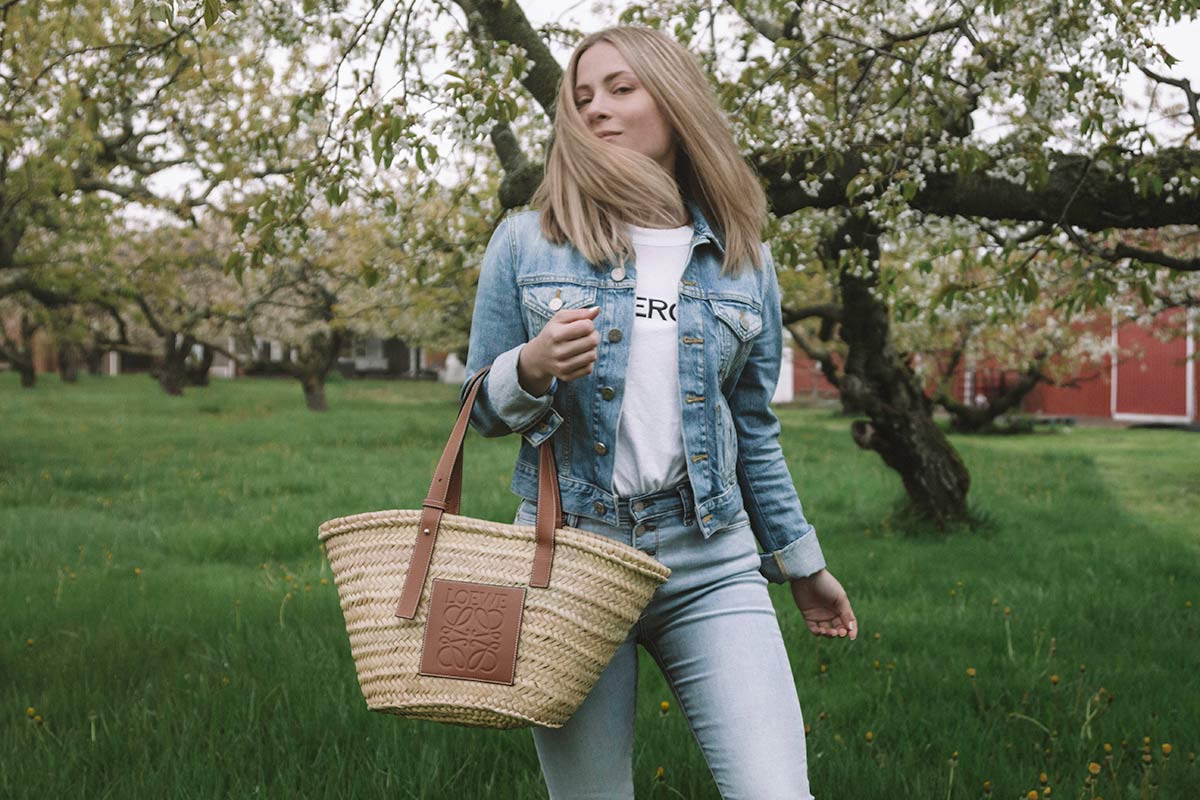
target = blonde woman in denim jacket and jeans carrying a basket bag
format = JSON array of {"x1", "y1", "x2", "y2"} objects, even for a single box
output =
[{"x1": 464, "y1": 26, "x2": 857, "y2": 800}]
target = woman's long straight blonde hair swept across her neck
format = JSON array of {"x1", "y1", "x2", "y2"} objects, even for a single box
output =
[{"x1": 530, "y1": 25, "x2": 767, "y2": 280}]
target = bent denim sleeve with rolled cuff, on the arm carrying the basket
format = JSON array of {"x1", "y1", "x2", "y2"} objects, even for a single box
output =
[{"x1": 458, "y1": 216, "x2": 563, "y2": 447}]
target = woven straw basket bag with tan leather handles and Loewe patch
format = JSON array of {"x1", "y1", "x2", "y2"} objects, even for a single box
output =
[{"x1": 318, "y1": 366, "x2": 671, "y2": 728}]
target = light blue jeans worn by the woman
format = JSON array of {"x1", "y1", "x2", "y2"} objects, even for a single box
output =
[{"x1": 514, "y1": 482, "x2": 812, "y2": 800}]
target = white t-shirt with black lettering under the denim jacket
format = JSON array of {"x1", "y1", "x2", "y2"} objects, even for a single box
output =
[{"x1": 612, "y1": 225, "x2": 692, "y2": 498}]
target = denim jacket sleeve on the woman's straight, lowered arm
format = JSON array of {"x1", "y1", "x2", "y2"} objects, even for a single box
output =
[{"x1": 730, "y1": 245, "x2": 826, "y2": 583}]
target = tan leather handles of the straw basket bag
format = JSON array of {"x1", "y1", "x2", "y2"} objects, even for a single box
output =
[{"x1": 396, "y1": 365, "x2": 563, "y2": 619}]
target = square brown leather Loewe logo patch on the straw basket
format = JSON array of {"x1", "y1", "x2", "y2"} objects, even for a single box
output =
[{"x1": 419, "y1": 578, "x2": 526, "y2": 686}]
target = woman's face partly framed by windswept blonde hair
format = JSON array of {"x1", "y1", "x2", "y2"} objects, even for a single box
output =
[{"x1": 575, "y1": 42, "x2": 676, "y2": 175}]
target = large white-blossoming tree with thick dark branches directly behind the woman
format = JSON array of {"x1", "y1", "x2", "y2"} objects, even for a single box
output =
[{"x1": 211, "y1": 0, "x2": 1200, "y2": 527}]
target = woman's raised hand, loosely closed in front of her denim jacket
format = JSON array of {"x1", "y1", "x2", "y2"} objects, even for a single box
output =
[{"x1": 517, "y1": 306, "x2": 600, "y2": 396}]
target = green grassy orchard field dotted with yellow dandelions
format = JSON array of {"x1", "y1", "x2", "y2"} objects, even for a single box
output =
[{"x1": 0, "y1": 373, "x2": 1200, "y2": 800}]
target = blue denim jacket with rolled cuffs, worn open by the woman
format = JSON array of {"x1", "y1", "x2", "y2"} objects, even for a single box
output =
[{"x1": 460, "y1": 195, "x2": 824, "y2": 583}]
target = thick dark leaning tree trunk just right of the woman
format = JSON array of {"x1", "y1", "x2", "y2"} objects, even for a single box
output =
[{"x1": 822, "y1": 217, "x2": 971, "y2": 530}]
